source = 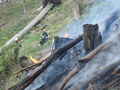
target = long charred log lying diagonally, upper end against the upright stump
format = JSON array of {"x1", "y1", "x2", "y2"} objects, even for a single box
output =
[{"x1": 9, "y1": 35, "x2": 82, "y2": 90}]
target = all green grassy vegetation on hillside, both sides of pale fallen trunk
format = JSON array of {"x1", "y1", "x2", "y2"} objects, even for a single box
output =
[{"x1": 0, "y1": 0, "x2": 86, "y2": 88}]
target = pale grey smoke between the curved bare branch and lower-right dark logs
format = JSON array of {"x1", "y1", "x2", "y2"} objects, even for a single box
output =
[{"x1": 66, "y1": 32, "x2": 120, "y2": 89}]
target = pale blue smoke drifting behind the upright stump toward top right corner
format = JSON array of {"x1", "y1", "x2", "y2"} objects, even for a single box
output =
[{"x1": 58, "y1": 0, "x2": 120, "y2": 38}]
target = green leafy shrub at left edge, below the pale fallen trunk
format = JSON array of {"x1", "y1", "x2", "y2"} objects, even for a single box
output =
[{"x1": 0, "y1": 44, "x2": 15, "y2": 79}]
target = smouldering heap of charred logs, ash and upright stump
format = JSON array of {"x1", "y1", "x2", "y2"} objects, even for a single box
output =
[{"x1": 9, "y1": 24, "x2": 120, "y2": 90}]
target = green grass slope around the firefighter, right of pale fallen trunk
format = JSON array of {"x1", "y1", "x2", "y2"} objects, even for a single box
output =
[{"x1": 20, "y1": 0, "x2": 72, "y2": 56}]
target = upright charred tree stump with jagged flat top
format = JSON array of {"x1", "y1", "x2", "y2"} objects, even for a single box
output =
[{"x1": 83, "y1": 24, "x2": 102, "y2": 54}]
